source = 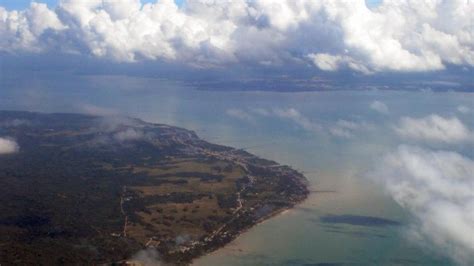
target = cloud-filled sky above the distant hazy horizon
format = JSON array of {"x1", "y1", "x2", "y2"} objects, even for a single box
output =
[{"x1": 0, "y1": 0, "x2": 474, "y2": 90}]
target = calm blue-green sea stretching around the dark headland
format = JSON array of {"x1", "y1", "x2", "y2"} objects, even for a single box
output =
[{"x1": 0, "y1": 74, "x2": 474, "y2": 265}]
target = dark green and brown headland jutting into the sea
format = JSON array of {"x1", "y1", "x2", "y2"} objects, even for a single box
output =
[{"x1": 0, "y1": 111, "x2": 309, "y2": 265}]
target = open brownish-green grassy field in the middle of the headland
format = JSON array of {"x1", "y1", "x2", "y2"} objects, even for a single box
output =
[{"x1": 126, "y1": 158, "x2": 245, "y2": 247}]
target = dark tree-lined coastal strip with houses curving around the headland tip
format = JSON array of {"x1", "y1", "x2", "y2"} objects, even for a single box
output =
[{"x1": 156, "y1": 135, "x2": 310, "y2": 265}]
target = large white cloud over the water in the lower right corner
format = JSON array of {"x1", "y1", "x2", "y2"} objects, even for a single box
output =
[{"x1": 373, "y1": 145, "x2": 474, "y2": 265}]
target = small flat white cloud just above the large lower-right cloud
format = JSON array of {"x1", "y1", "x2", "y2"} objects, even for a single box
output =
[{"x1": 395, "y1": 114, "x2": 474, "y2": 143}]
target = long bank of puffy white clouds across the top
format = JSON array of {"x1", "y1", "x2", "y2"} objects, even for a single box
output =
[{"x1": 0, "y1": 0, "x2": 474, "y2": 74}]
